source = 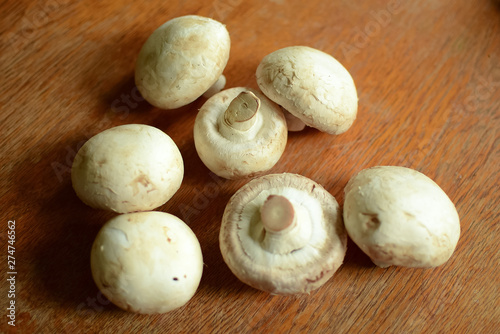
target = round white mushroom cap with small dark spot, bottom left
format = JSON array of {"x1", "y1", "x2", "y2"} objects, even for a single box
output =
[{"x1": 90, "y1": 211, "x2": 203, "y2": 314}]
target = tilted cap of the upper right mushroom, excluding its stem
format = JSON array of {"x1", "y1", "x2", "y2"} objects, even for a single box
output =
[{"x1": 256, "y1": 46, "x2": 358, "y2": 134}]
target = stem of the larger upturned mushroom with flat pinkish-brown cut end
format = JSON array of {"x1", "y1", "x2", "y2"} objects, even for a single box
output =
[{"x1": 260, "y1": 195, "x2": 311, "y2": 254}]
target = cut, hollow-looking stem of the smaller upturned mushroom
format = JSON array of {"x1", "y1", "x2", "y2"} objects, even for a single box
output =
[{"x1": 224, "y1": 91, "x2": 260, "y2": 131}]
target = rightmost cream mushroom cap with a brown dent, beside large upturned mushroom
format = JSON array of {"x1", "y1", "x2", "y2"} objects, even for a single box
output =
[{"x1": 344, "y1": 166, "x2": 460, "y2": 267}]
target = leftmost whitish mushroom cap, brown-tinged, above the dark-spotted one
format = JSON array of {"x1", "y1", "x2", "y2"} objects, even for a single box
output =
[{"x1": 71, "y1": 124, "x2": 184, "y2": 213}]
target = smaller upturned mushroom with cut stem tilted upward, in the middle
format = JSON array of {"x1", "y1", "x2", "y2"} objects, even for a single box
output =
[{"x1": 194, "y1": 87, "x2": 287, "y2": 179}]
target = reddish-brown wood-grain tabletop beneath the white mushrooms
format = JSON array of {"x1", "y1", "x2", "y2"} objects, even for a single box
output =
[{"x1": 0, "y1": 0, "x2": 500, "y2": 333}]
